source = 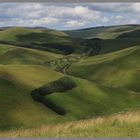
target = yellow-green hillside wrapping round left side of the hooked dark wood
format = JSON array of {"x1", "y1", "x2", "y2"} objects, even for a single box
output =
[{"x1": 0, "y1": 65, "x2": 64, "y2": 129}]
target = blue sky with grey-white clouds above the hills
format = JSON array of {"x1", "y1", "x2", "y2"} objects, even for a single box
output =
[{"x1": 0, "y1": 3, "x2": 140, "y2": 30}]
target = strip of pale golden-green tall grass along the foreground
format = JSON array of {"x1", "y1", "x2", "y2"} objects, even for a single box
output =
[{"x1": 0, "y1": 111, "x2": 140, "y2": 137}]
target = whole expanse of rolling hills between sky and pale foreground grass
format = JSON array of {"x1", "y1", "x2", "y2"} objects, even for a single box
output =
[{"x1": 0, "y1": 25, "x2": 140, "y2": 136}]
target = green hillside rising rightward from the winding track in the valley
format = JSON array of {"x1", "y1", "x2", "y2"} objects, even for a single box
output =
[{"x1": 69, "y1": 46, "x2": 140, "y2": 92}]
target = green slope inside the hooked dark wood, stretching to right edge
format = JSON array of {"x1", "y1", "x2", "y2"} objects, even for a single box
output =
[{"x1": 43, "y1": 79, "x2": 139, "y2": 120}]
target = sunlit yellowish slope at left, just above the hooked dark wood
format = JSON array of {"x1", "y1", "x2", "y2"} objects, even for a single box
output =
[{"x1": 0, "y1": 65, "x2": 61, "y2": 89}]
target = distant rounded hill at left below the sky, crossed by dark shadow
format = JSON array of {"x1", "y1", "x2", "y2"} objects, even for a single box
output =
[{"x1": 0, "y1": 27, "x2": 84, "y2": 54}]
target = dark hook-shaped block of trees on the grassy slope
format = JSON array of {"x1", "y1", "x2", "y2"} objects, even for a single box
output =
[{"x1": 31, "y1": 77, "x2": 76, "y2": 115}]
